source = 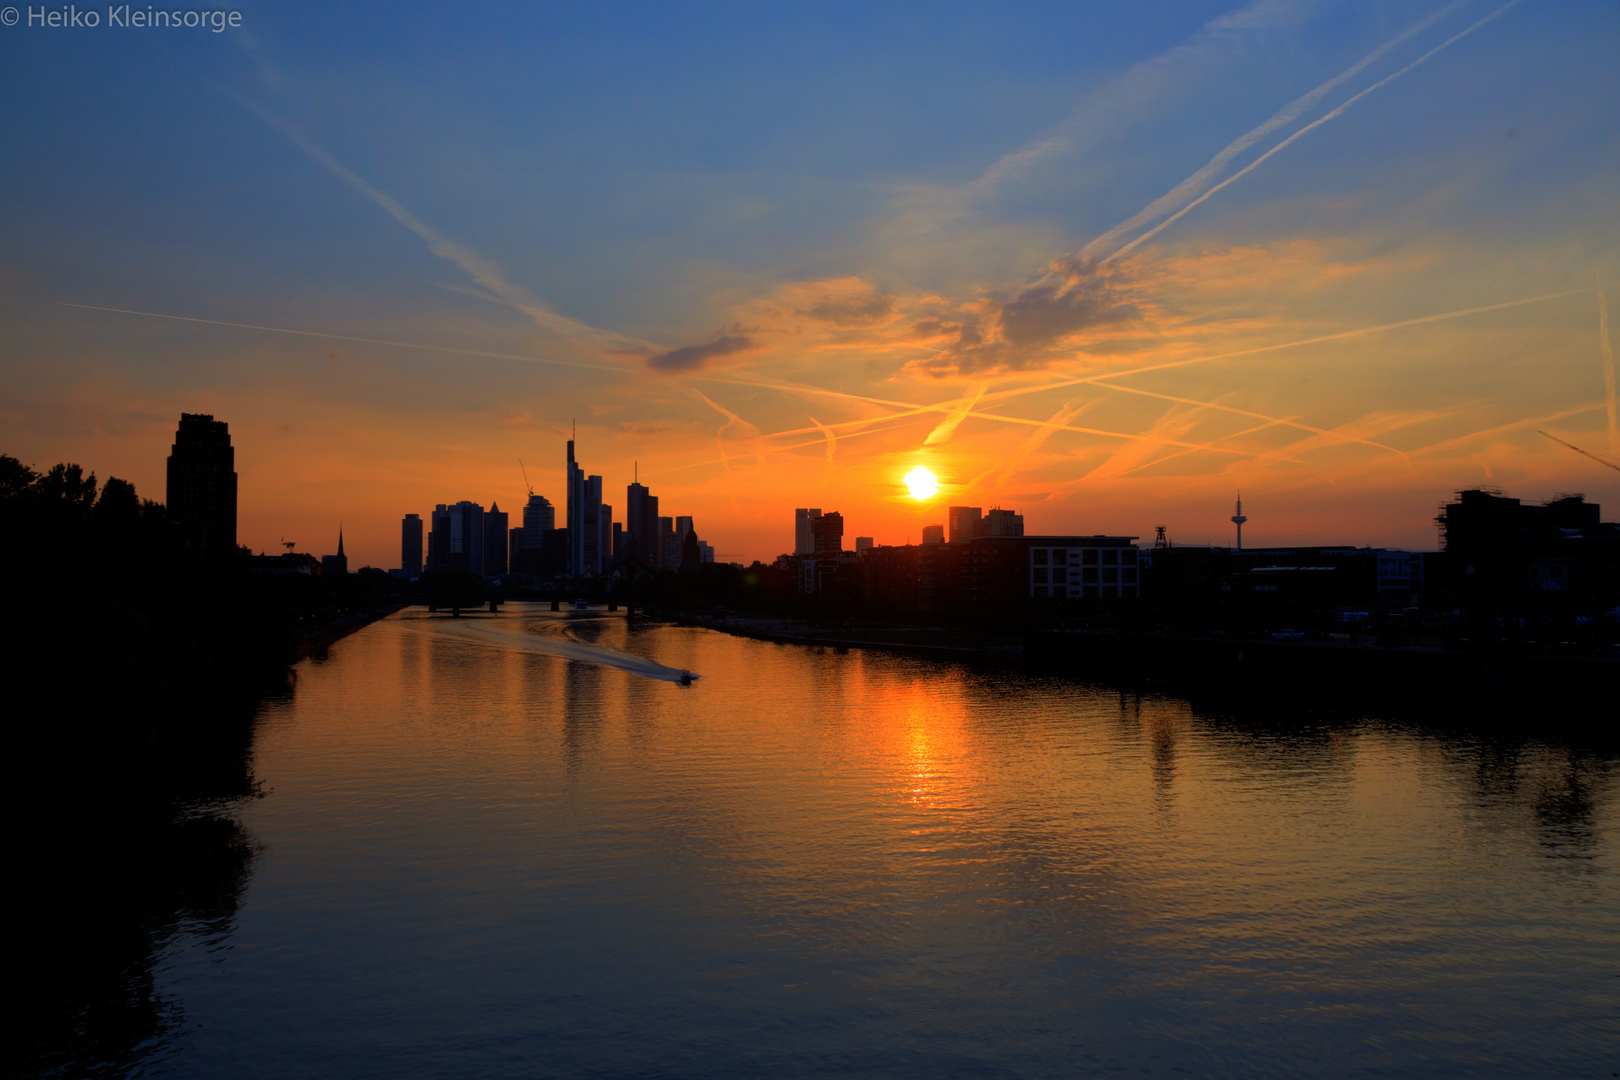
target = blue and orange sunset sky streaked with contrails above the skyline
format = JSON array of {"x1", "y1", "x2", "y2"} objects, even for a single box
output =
[{"x1": 0, "y1": 0, "x2": 1620, "y2": 567}]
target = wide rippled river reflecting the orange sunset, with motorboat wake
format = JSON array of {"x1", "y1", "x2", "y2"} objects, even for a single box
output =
[{"x1": 123, "y1": 606, "x2": 1620, "y2": 1078}]
